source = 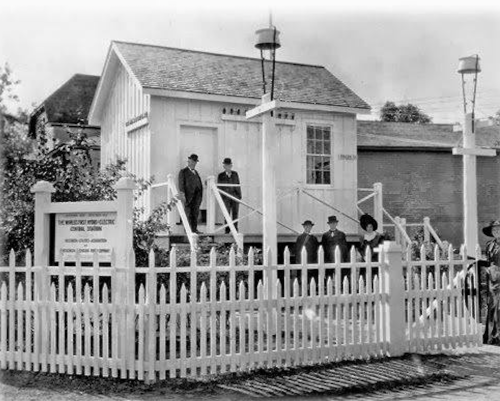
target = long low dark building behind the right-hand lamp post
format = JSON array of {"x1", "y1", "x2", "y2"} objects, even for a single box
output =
[{"x1": 358, "y1": 121, "x2": 500, "y2": 246}]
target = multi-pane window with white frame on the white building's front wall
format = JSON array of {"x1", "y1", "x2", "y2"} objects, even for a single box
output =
[{"x1": 306, "y1": 125, "x2": 332, "y2": 184}]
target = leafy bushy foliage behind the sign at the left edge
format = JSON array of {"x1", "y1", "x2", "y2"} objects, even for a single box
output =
[{"x1": 0, "y1": 67, "x2": 176, "y2": 258}]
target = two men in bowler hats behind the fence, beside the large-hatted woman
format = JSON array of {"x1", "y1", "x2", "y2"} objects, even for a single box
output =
[{"x1": 295, "y1": 216, "x2": 348, "y2": 263}]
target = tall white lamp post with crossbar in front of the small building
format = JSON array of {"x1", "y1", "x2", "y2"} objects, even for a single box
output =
[{"x1": 246, "y1": 18, "x2": 281, "y2": 268}]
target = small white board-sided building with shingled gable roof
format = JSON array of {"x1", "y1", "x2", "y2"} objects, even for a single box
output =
[{"x1": 89, "y1": 42, "x2": 370, "y2": 241}]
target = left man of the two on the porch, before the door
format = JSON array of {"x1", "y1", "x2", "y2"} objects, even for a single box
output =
[{"x1": 179, "y1": 153, "x2": 203, "y2": 234}]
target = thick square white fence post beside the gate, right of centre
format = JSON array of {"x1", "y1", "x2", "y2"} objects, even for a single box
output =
[{"x1": 382, "y1": 241, "x2": 406, "y2": 357}]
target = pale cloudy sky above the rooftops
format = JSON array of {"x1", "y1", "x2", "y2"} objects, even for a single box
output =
[{"x1": 0, "y1": 0, "x2": 500, "y2": 123}]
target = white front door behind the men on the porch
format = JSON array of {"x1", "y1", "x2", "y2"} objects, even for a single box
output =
[{"x1": 179, "y1": 125, "x2": 220, "y2": 223}]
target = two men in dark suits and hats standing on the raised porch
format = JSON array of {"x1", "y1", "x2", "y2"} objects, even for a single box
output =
[{"x1": 179, "y1": 153, "x2": 241, "y2": 234}]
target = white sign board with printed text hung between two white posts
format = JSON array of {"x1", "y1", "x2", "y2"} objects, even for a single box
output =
[{"x1": 54, "y1": 212, "x2": 118, "y2": 262}]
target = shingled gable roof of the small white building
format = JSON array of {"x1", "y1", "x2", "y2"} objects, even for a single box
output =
[{"x1": 114, "y1": 42, "x2": 370, "y2": 109}]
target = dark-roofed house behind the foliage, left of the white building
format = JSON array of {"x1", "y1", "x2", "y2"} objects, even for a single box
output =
[{"x1": 29, "y1": 74, "x2": 100, "y2": 166}]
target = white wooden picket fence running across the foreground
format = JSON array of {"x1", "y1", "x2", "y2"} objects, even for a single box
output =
[{"x1": 0, "y1": 243, "x2": 481, "y2": 381}]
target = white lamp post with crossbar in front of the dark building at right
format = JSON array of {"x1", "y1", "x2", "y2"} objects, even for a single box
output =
[{"x1": 453, "y1": 55, "x2": 496, "y2": 257}]
